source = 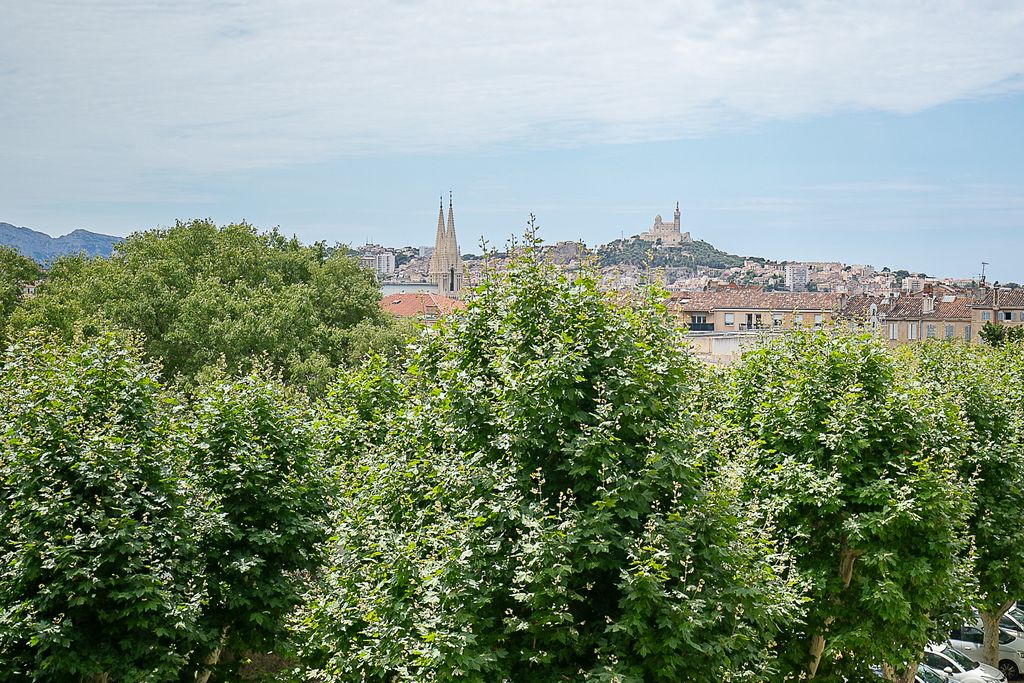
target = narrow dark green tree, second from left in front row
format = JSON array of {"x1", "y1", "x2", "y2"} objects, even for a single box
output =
[{"x1": 179, "y1": 373, "x2": 327, "y2": 666}]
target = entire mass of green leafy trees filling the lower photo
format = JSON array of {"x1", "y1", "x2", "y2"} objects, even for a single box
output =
[{"x1": 0, "y1": 225, "x2": 1024, "y2": 683}]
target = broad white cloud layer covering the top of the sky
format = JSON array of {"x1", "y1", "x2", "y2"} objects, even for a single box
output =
[{"x1": 0, "y1": 0, "x2": 1024, "y2": 187}]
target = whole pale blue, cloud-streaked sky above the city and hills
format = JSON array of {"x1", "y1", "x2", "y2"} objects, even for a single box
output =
[{"x1": 0, "y1": 0, "x2": 1024, "y2": 282}]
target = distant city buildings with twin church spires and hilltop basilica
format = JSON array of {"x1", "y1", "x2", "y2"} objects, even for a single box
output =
[{"x1": 337, "y1": 194, "x2": 1024, "y2": 362}]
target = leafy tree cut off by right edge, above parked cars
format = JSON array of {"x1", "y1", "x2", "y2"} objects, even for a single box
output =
[{"x1": 911, "y1": 342, "x2": 1024, "y2": 679}]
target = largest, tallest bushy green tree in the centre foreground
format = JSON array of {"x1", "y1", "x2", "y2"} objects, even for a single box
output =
[{"x1": 295, "y1": 248, "x2": 795, "y2": 682}]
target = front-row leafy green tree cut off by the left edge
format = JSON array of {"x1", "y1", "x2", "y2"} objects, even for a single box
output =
[{"x1": 0, "y1": 336, "x2": 198, "y2": 681}]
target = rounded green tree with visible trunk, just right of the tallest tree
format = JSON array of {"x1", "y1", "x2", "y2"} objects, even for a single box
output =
[{"x1": 731, "y1": 331, "x2": 970, "y2": 680}]
